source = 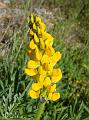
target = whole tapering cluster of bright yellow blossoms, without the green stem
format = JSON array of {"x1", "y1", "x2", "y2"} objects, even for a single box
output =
[{"x1": 25, "y1": 14, "x2": 62, "y2": 101}]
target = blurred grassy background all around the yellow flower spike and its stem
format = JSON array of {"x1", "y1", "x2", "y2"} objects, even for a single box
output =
[{"x1": 0, "y1": 0, "x2": 89, "y2": 120}]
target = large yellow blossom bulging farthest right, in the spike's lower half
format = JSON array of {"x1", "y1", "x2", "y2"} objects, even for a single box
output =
[{"x1": 51, "y1": 69, "x2": 62, "y2": 83}]
